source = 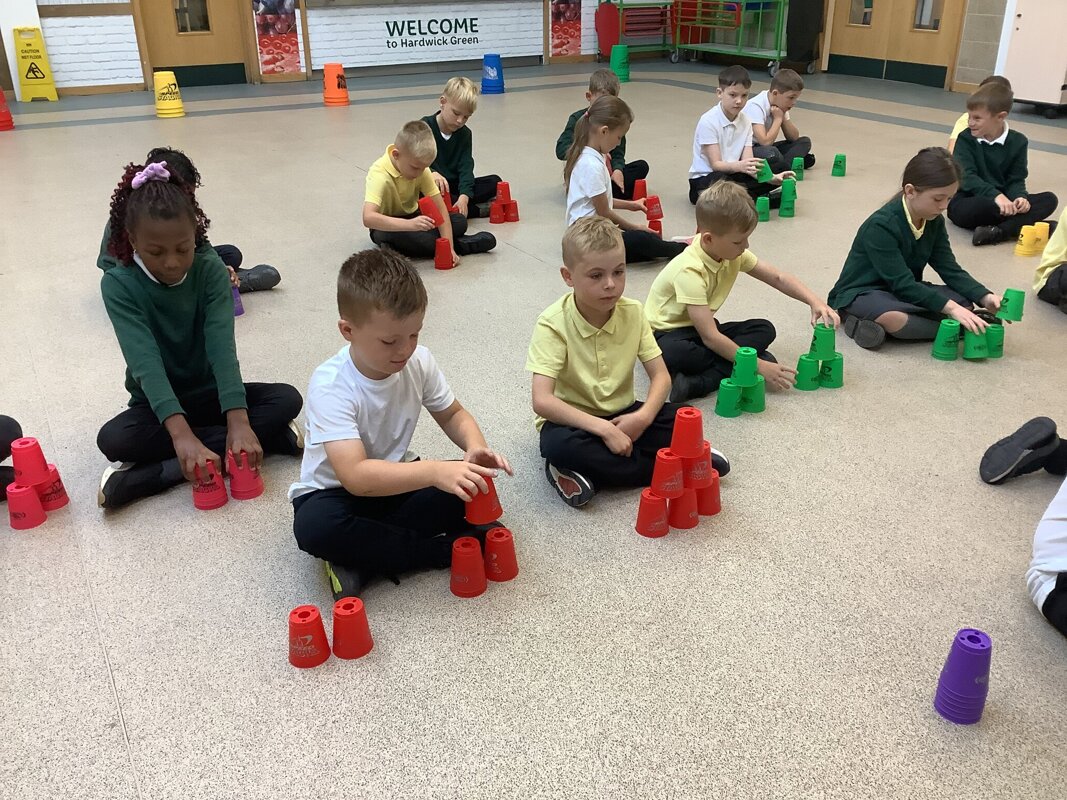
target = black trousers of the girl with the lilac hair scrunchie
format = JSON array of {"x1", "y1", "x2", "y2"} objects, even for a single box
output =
[{"x1": 96, "y1": 383, "x2": 304, "y2": 464}]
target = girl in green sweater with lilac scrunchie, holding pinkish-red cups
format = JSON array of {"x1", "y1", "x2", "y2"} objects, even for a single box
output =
[{"x1": 97, "y1": 162, "x2": 303, "y2": 508}]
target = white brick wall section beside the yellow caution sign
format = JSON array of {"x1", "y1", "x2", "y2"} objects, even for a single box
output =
[{"x1": 41, "y1": 16, "x2": 144, "y2": 89}]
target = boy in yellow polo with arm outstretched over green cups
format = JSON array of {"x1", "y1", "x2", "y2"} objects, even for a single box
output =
[{"x1": 644, "y1": 180, "x2": 841, "y2": 402}]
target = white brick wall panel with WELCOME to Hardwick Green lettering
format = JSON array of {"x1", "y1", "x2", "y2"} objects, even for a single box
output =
[{"x1": 307, "y1": 0, "x2": 544, "y2": 69}]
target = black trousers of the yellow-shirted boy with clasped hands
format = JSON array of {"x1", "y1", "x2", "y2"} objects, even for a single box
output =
[{"x1": 541, "y1": 402, "x2": 682, "y2": 489}]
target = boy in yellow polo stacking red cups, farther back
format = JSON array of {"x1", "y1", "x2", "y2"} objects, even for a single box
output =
[{"x1": 363, "y1": 119, "x2": 496, "y2": 266}]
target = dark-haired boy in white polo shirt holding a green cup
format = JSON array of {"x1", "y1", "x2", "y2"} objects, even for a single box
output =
[{"x1": 689, "y1": 65, "x2": 793, "y2": 207}]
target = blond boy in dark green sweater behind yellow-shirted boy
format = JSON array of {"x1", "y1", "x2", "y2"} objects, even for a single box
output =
[{"x1": 423, "y1": 78, "x2": 500, "y2": 219}]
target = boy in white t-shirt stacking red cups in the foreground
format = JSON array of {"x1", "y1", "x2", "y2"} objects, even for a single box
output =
[{"x1": 289, "y1": 250, "x2": 511, "y2": 599}]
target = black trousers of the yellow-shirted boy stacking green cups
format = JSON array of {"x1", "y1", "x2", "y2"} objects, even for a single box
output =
[{"x1": 654, "y1": 319, "x2": 777, "y2": 397}]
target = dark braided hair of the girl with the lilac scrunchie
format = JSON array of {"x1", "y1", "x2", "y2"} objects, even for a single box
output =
[{"x1": 108, "y1": 164, "x2": 211, "y2": 263}]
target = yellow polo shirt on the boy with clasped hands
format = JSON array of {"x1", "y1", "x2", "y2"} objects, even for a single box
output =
[{"x1": 526, "y1": 292, "x2": 662, "y2": 431}]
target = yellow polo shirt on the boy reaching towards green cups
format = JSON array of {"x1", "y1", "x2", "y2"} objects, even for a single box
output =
[{"x1": 644, "y1": 237, "x2": 759, "y2": 331}]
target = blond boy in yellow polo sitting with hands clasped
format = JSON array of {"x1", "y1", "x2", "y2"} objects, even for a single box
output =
[{"x1": 526, "y1": 217, "x2": 729, "y2": 508}]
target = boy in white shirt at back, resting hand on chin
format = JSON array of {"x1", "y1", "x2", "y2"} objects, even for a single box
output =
[{"x1": 744, "y1": 69, "x2": 815, "y2": 172}]
